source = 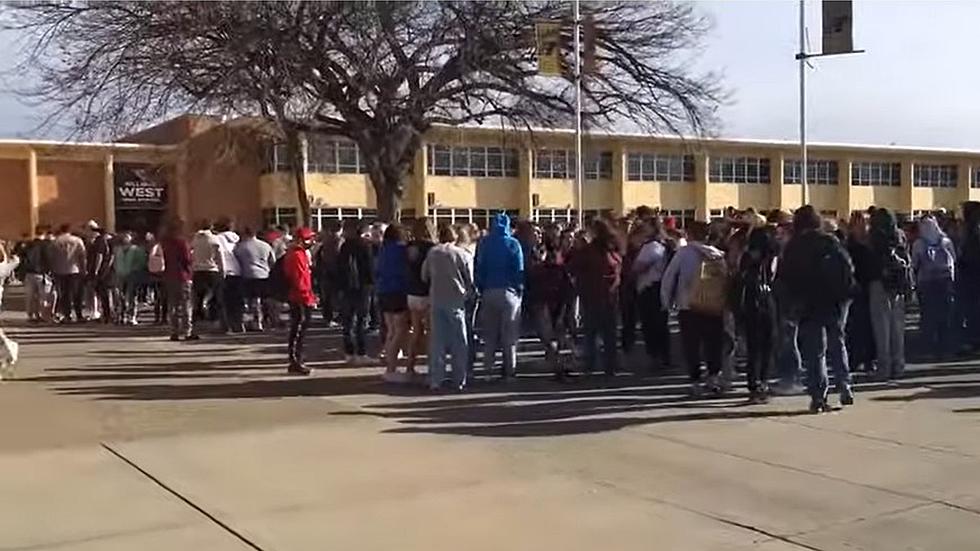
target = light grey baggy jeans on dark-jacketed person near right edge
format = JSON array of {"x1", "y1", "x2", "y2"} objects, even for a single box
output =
[{"x1": 869, "y1": 281, "x2": 905, "y2": 379}]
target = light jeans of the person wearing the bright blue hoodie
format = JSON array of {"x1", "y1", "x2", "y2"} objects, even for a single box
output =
[{"x1": 480, "y1": 289, "x2": 521, "y2": 377}]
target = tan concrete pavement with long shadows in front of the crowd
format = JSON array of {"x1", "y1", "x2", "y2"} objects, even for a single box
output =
[{"x1": 0, "y1": 296, "x2": 980, "y2": 551}]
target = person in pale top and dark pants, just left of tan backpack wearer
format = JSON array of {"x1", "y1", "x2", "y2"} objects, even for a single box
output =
[{"x1": 633, "y1": 217, "x2": 675, "y2": 371}]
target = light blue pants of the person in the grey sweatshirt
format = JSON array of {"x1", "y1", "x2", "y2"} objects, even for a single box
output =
[{"x1": 429, "y1": 304, "x2": 469, "y2": 388}]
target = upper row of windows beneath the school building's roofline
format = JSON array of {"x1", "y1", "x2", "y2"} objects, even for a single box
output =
[{"x1": 266, "y1": 142, "x2": 980, "y2": 188}]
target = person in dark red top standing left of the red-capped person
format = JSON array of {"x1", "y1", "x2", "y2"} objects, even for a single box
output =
[{"x1": 160, "y1": 220, "x2": 200, "y2": 341}]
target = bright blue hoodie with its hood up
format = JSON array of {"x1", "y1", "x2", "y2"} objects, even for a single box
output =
[{"x1": 474, "y1": 213, "x2": 524, "y2": 292}]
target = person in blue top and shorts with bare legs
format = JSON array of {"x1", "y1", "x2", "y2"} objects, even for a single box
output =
[{"x1": 375, "y1": 224, "x2": 415, "y2": 382}]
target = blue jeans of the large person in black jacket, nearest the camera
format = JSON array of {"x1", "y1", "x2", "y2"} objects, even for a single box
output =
[{"x1": 799, "y1": 302, "x2": 851, "y2": 402}]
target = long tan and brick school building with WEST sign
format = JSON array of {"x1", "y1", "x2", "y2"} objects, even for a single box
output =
[{"x1": 0, "y1": 116, "x2": 980, "y2": 239}]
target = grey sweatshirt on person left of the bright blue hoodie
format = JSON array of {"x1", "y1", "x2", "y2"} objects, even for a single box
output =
[{"x1": 422, "y1": 243, "x2": 473, "y2": 308}]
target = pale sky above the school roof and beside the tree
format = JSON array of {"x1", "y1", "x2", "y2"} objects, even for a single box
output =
[{"x1": 0, "y1": 0, "x2": 980, "y2": 149}]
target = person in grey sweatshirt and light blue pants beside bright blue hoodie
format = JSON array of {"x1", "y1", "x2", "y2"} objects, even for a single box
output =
[{"x1": 422, "y1": 225, "x2": 473, "y2": 391}]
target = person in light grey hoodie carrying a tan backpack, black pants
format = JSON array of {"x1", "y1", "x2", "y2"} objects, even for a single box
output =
[{"x1": 660, "y1": 222, "x2": 728, "y2": 397}]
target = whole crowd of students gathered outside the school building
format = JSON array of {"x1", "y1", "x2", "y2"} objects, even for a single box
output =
[{"x1": 0, "y1": 202, "x2": 980, "y2": 412}]
